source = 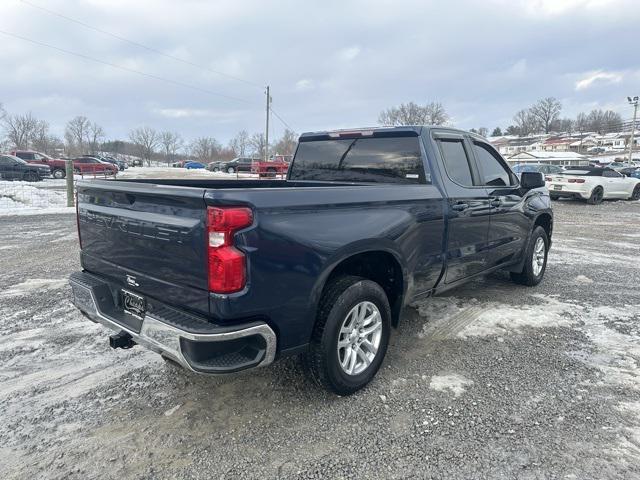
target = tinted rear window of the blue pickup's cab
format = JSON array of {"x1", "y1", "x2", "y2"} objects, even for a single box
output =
[{"x1": 289, "y1": 137, "x2": 429, "y2": 184}]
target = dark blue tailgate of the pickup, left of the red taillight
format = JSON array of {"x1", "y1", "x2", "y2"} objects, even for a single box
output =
[{"x1": 78, "y1": 181, "x2": 209, "y2": 313}]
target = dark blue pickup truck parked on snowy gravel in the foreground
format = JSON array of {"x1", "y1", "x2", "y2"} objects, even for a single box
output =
[{"x1": 70, "y1": 127, "x2": 553, "y2": 395}]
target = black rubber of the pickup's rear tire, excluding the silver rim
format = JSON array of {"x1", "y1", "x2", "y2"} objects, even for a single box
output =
[{"x1": 302, "y1": 275, "x2": 391, "y2": 395}]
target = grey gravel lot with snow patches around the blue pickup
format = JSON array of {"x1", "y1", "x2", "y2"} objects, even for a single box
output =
[{"x1": 0, "y1": 201, "x2": 640, "y2": 479}]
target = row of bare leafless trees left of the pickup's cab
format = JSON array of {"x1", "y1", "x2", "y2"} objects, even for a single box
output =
[{"x1": 0, "y1": 104, "x2": 298, "y2": 164}]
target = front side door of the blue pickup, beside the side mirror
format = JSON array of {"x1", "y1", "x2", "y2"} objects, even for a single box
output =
[{"x1": 470, "y1": 138, "x2": 530, "y2": 267}]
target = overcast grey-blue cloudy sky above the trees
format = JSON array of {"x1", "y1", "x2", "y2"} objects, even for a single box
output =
[{"x1": 0, "y1": 0, "x2": 640, "y2": 143}]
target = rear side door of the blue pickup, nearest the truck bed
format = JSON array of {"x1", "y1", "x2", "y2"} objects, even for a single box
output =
[{"x1": 433, "y1": 131, "x2": 491, "y2": 283}]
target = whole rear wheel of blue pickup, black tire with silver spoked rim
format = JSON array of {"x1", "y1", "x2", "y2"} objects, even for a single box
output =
[{"x1": 302, "y1": 276, "x2": 391, "y2": 395}]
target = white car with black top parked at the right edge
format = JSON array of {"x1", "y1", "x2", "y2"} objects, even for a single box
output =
[{"x1": 545, "y1": 167, "x2": 640, "y2": 205}]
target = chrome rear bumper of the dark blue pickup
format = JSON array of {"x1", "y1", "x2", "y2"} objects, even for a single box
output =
[{"x1": 69, "y1": 272, "x2": 277, "y2": 374}]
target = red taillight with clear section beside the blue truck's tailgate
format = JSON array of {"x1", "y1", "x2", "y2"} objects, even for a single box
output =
[{"x1": 207, "y1": 207, "x2": 253, "y2": 293}]
